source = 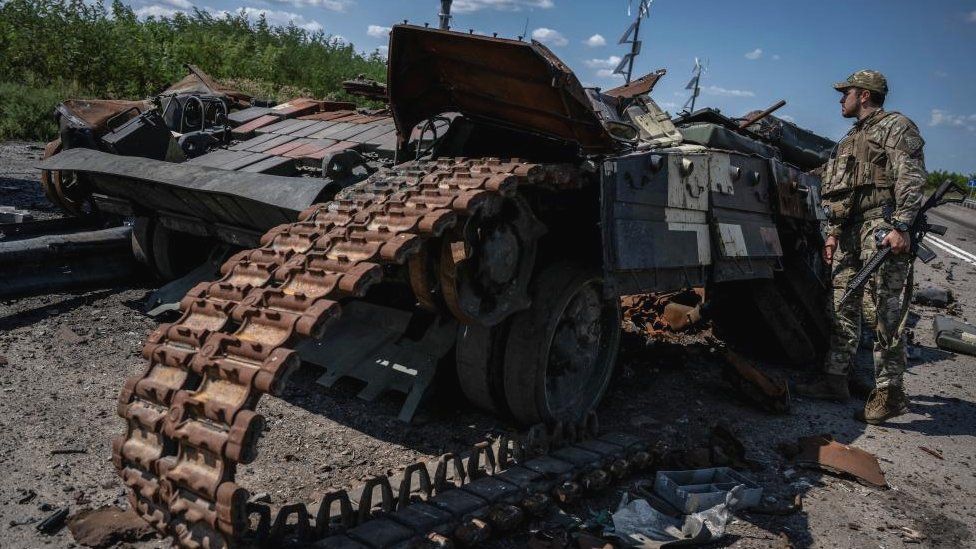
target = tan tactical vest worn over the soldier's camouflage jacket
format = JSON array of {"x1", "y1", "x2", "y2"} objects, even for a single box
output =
[{"x1": 822, "y1": 112, "x2": 898, "y2": 222}]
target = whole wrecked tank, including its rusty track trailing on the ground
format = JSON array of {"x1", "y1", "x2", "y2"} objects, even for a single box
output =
[{"x1": 30, "y1": 25, "x2": 832, "y2": 548}]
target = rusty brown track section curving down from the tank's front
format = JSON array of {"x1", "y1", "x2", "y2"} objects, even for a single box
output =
[{"x1": 112, "y1": 159, "x2": 578, "y2": 548}]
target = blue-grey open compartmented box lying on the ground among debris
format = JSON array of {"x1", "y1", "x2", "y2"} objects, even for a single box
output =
[{"x1": 654, "y1": 467, "x2": 762, "y2": 515}]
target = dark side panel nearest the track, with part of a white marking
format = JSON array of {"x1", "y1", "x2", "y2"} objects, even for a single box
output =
[{"x1": 601, "y1": 151, "x2": 712, "y2": 293}]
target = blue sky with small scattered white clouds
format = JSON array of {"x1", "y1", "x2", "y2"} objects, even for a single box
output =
[{"x1": 132, "y1": 0, "x2": 976, "y2": 173}]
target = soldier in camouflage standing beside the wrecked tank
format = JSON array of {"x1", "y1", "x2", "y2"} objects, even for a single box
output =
[{"x1": 797, "y1": 70, "x2": 926, "y2": 423}]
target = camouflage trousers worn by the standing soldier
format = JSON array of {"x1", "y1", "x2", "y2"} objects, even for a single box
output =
[{"x1": 825, "y1": 219, "x2": 912, "y2": 387}]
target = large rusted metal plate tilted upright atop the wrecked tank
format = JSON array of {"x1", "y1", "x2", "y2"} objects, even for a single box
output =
[{"x1": 387, "y1": 25, "x2": 613, "y2": 152}]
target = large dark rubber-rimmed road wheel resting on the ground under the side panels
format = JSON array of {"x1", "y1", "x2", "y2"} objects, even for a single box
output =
[{"x1": 504, "y1": 263, "x2": 620, "y2": 424}]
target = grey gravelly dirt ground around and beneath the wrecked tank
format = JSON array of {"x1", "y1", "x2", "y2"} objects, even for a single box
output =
[{"x1": 0, "y1": 142, "x2": 976, "y2": 548}]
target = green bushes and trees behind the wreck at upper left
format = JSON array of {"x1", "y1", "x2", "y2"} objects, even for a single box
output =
[{"x1": 0, "y1": 0, "x2": 386, "y2": 139}]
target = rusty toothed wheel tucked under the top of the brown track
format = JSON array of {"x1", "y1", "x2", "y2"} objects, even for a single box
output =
[{"x1": 436, "y1": 197, "x2": 545, "y2": 326}]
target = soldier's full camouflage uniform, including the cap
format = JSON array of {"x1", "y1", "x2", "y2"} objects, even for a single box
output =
[{"x1": 822, "y1": 71, "x2": 926, "y2": 388}]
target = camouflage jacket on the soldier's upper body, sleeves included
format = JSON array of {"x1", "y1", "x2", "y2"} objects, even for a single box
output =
[{"x1": 821, "y1": 109, "x2": 926, "y2": 236}]
